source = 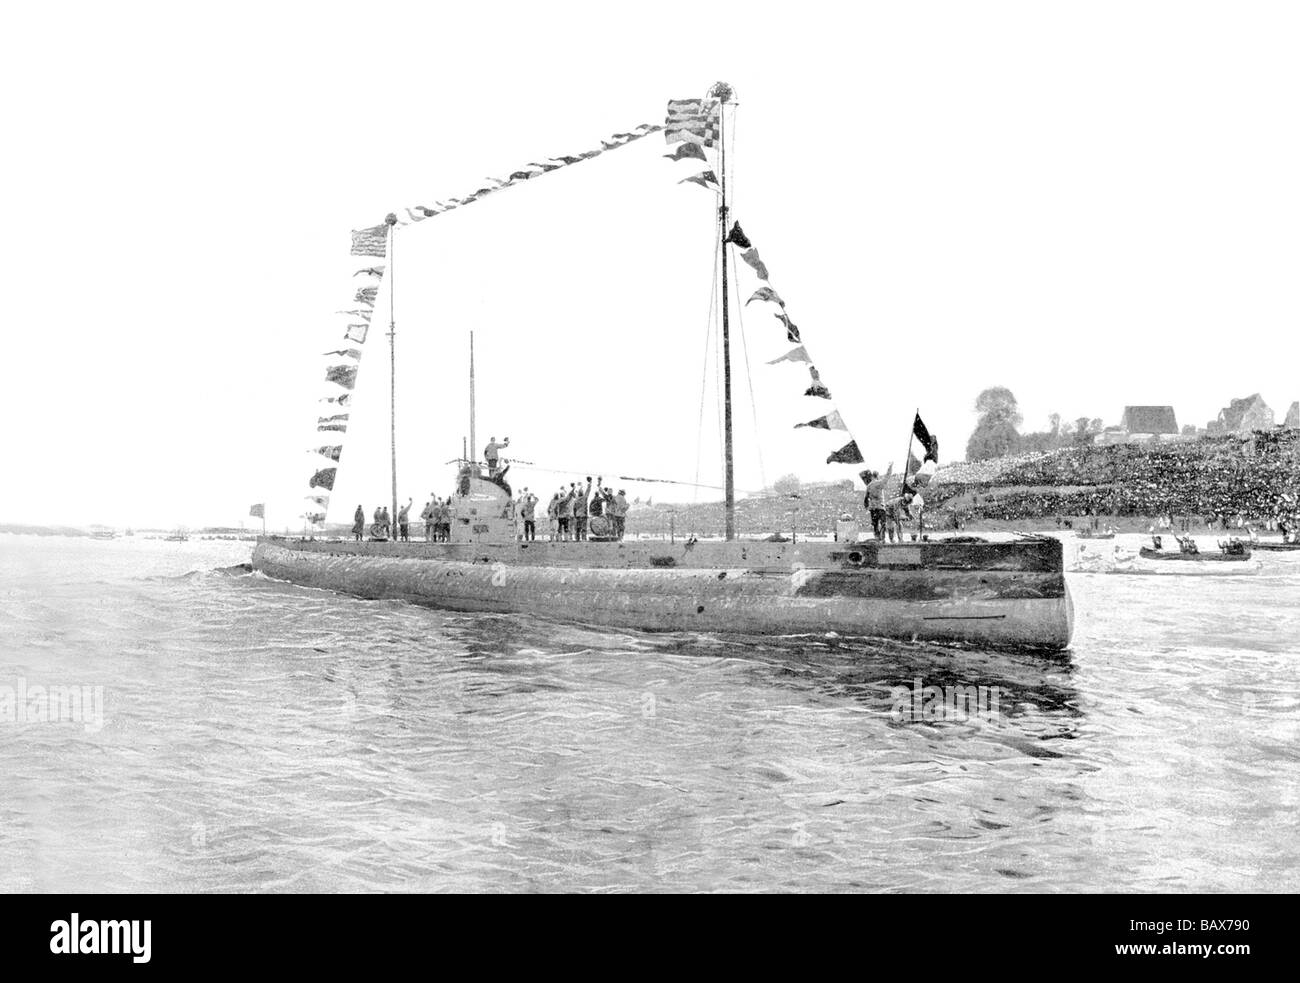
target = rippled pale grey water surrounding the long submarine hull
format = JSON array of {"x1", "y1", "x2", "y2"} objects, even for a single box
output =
[{"x1": 0, "y1": 536, "x2": 1300, "y2": 892}]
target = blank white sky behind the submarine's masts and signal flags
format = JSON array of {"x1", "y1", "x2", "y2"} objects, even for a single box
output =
[{"x1": 0, "y1": 1, "x2": 1300, "y2": 528}]
